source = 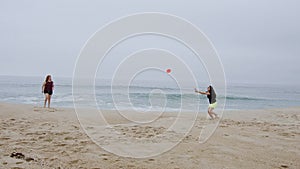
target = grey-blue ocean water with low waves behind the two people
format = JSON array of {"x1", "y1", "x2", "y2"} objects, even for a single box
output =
[{"x1": 0, "y1": 76, "x2": 300, "y2": 112}]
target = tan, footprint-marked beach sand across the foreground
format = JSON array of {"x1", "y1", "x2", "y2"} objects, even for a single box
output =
[{"x1": 0, "y1": 103, "x2": 300, "y2": 169}]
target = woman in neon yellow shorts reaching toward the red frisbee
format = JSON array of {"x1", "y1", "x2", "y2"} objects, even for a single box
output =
[{"x1": 195, "y1": 86, "x2": 218, "y2": 119}]
